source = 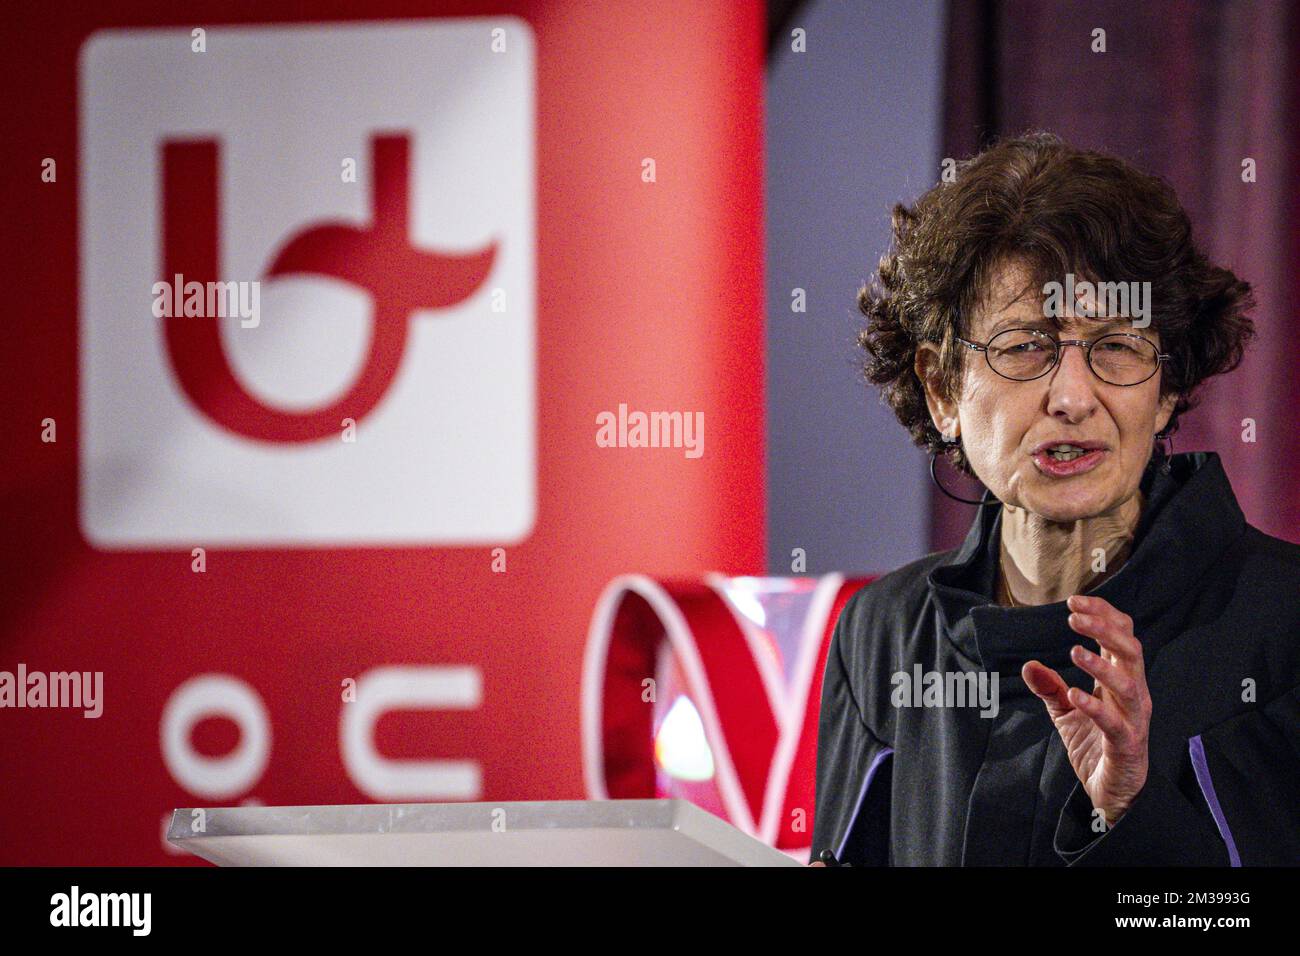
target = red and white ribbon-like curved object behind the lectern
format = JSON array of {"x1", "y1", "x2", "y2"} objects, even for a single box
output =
[{"x1": 582, "y1": 575, "x2": 871, "y2": 849}]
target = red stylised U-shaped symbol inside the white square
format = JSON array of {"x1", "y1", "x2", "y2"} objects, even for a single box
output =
[{"x1": 163, "y1": 135, "x2": 497, "y2": 442}]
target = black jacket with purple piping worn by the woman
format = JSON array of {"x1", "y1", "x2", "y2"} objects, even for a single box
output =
[{"x1": 813, "y1": 453, "x2": 1300, "y2": 866}]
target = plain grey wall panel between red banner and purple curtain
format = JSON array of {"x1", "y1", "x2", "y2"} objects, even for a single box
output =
[{"x1": 766, "y1": 0, "x2": 945, "y2": 574}]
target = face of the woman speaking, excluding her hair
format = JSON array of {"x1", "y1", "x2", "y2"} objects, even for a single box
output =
[{"x1": 918, "y1": 263, "x2": 1177, "y2": 522}]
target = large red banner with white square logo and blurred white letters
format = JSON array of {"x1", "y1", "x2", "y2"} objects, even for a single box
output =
[{"x1": 0, "y1": 0, "x2": 764, "y2": 865}]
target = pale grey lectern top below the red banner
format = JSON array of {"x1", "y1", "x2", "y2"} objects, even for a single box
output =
[{"x1": 166, "y1": 800, "x2": 801, "y2": 866}]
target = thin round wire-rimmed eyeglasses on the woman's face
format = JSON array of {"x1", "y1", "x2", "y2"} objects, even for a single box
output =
[{"x1": 957, "y1": 329, "x2": 1173, "y2": 386}]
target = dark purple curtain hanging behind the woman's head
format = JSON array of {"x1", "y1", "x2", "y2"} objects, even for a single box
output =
[{"x1": 931, "y1": 0, "x2": 1300, "y2": 549}]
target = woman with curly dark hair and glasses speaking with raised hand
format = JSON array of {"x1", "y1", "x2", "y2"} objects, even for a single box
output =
[{"x1": 813, "y1": 134, "x2": 1300, "y2": 866}]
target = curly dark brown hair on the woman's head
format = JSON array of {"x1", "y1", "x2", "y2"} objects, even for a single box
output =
[{"x1": 858, "y1": 131, "x2": 1255, "y2": 475}]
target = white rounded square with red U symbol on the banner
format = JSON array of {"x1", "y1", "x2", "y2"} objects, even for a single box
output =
[{"x1": 79, "y1": 17, "x2": 537, "y2": 549}]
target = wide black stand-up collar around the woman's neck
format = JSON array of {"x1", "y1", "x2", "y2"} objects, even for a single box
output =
[{"x1": 928, "y1": 451, "x2": 1245, "y2": 683}]
